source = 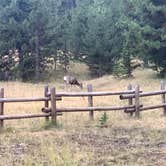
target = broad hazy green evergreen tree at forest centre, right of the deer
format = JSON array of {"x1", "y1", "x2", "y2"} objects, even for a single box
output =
[{"x1": 71, "y1": 0, "x2": 122, "y2": 76}]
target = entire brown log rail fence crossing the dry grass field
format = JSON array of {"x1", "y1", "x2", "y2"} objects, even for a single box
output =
[{"x1": 0, "y1": 82, "x2": 166, "y2": 127}]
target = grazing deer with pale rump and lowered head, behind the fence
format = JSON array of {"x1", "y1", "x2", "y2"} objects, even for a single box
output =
[{"x1": 63, "y1": 75, "x2": 83, "y2": 89}]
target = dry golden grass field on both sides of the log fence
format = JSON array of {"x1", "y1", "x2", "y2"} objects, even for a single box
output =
[{"x1": 0, "y1": 69, "x2": 166, "y2": 166}]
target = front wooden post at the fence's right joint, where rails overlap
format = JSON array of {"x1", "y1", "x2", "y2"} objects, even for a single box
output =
[{"x1": 135, "y1": 85, "x2": 140, "y2": 118}]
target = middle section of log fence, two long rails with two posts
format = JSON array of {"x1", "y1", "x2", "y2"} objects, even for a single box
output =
[{"x1": 42, "y1": 85, "x2": 141, "y2": 124}]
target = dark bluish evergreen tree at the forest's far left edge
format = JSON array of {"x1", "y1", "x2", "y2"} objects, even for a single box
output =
[{"x1": 0, "y1": 0, "x2": 32, "y2": 80}]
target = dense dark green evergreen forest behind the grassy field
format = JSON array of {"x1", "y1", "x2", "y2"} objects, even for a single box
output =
[{"x1": 0, "y1": 0, "x2": 166, "y2": 81}]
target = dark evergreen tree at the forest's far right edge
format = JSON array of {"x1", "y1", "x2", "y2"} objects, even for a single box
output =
[{"x1": 142, "y1": 0, "x2": 166, "y2": 77}]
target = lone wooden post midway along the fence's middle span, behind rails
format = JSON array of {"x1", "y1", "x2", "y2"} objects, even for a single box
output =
[{"x1": 87, "y1": 84, "x2": 94, "y2": 120}]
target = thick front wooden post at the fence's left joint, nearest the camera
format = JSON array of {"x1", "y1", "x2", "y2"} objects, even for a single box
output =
[{"x1": 50, "y1": 88, "x2": 57, "y2": 125}]
